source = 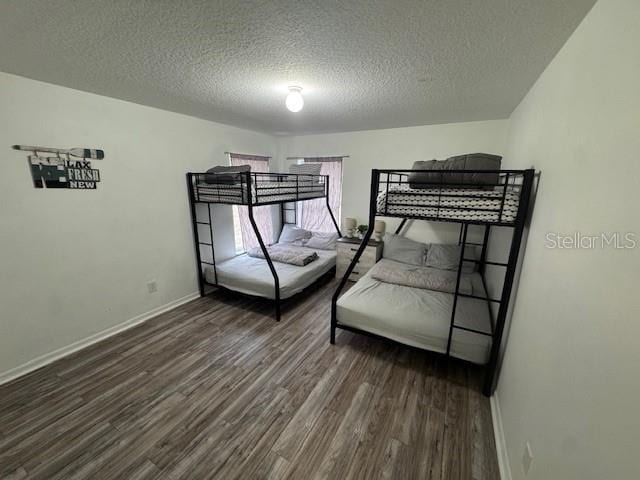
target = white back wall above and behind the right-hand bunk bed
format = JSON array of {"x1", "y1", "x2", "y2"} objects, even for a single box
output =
[{"x1": 279, "y1": 120, "x2": 508, "y2": 242}]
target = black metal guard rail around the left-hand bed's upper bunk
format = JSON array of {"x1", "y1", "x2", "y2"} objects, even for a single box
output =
[{"x1": 187, "y1": 172, "x2": 329, "y2": 205}]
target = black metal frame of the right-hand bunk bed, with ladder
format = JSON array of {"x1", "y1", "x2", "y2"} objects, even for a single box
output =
[{"x1": 330, "y1": 169, "x2": 535, "y2": 396}]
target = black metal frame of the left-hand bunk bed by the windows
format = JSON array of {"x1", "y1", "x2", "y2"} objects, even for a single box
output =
[{"x1": 186, "y1": 172, "x2": 341, "y2": 321}]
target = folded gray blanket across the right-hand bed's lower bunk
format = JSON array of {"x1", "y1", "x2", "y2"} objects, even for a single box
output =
[{"x1": 371, "y1": 263, "x2": 473, "y2": 295}]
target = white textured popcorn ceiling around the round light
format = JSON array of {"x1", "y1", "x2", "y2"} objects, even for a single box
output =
[{"x1": 0, "y1": 0, "x2": 594, "y2": 134}]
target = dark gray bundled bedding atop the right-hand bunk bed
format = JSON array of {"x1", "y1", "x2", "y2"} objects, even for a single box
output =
[{"x1": 409, "y1": 153, "x2": 502, "y2": 190}]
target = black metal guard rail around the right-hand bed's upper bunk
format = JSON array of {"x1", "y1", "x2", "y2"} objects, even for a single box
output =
[{"x1": 375, "y1": 170, "x2": 526, "y2": 226}]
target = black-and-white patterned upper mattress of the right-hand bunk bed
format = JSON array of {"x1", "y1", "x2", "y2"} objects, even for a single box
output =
[{"x1": 377, "y1": 185, "x2": 520, "y2": 223}]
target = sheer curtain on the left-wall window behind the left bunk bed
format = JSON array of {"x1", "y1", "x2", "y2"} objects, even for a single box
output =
[{"x1": 229, "y1": 153, "x2": 273, "y2": 251}]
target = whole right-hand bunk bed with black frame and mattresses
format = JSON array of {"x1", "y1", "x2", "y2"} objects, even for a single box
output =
[{"x1": 330, "y1": 169, "x2": 535, "y2": 396}]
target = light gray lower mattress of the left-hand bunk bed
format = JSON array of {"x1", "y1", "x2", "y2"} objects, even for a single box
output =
[{"x1": 204, "y1": 247, "x2": 336, "y2": 299}]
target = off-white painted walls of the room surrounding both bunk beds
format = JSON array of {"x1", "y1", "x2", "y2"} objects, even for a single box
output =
[{"x1": 5, "y1": 0, "x2": 640, "y2": 480}]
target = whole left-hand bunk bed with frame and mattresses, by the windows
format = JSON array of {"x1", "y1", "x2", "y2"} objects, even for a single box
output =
[{"x1": 186, "y1": 171, "x2": 340, "y2": 321}]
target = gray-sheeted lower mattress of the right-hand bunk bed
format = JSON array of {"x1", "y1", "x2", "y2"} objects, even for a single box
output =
[{"x1": 337, "y1": 259, "x2": 491, "y2": 364}]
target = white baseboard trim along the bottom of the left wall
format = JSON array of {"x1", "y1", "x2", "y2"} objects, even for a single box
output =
[{"x1": 0, "y1": 292, "x2": 200, "y2": 385}]
